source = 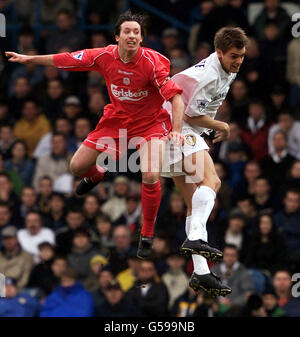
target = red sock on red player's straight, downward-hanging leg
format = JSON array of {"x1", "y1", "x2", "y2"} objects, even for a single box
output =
[{"x1": 142, "y1": 181, "x2": 161, "y2": 237}]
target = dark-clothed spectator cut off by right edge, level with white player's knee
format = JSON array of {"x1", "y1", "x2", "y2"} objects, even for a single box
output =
[{"x1": 274, "y1": 188, "x2": 300, "y2": 254}]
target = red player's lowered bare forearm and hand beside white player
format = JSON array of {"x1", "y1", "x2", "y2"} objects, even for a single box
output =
[{"x1": 169, "y1": 94, "x2": 184, "y2": 144}]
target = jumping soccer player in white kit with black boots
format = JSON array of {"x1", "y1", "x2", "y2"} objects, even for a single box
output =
[{"x1": 162, "y1": 27, "x2": 248, "y2": 297}]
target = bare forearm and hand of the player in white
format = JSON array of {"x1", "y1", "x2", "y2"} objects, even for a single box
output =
[{"x1": 185, "y1": 115, "x2": 230, "y2": 143}]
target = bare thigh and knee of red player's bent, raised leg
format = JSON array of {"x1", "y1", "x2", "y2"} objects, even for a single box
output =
[{"x1": 70, "y1": 144, "x2": 99, "y2": 174}]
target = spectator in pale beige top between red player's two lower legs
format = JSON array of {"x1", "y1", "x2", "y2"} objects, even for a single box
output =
[{"x1": 101, "y1": 176, "x2": 129, "y2": 222}]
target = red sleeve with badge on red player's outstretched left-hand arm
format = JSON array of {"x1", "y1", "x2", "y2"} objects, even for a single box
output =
[{"x1": 53, "y1": 48, "x2": 105, "y2": 71}]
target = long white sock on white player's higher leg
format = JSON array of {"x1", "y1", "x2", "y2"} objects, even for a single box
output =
[{"x1": 188, "y1": 186, "x2": 216, "y2": 242}]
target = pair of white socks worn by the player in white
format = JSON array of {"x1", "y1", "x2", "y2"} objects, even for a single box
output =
[{"x1": 185, "y1": 186, "x2": 216, "y2": 275}]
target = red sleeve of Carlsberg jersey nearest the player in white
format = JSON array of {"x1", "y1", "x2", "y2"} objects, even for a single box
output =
[{"x1": 151, "y1": 51, "x2": 182, "y2": 101}]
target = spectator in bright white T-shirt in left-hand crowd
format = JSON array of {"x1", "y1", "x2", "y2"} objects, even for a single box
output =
[{"x1": 17, "y1": 211, "x2": 55, "y2": 263}]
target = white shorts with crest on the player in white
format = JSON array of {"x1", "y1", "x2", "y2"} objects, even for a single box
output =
[{"x1": 160, "y1": 128, "x2": 209, "y2": 178}]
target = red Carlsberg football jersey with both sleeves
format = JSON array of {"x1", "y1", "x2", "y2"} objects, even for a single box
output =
[{"x1": 53, "y1": 45, "x2": 182, "y2": 137}]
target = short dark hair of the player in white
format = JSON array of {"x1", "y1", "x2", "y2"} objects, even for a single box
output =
[{"x1": 214, "y1": 27, "x2": 248, "y2": 53}]
